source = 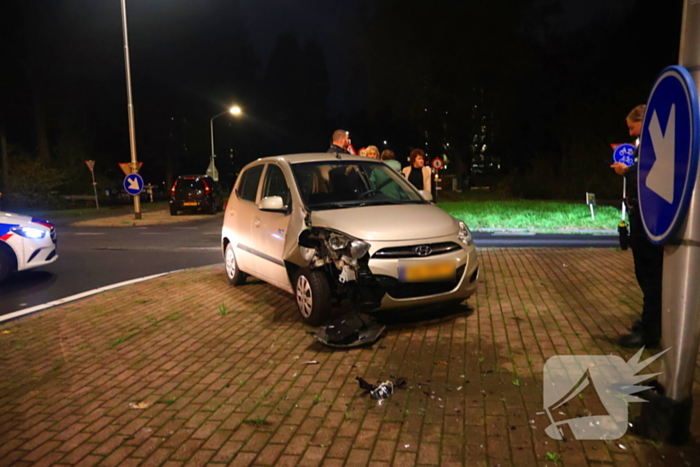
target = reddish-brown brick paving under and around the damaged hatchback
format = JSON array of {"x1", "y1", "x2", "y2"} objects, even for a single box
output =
[{"x1": 0, "y1": 249, "x2": 700, "y2": 467}]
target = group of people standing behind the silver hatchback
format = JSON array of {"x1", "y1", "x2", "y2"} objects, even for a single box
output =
[{"x1": 326, "y1": 130, "x2": 432, "y2": 192}]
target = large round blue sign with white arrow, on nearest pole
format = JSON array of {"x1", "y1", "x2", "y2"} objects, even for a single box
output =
[{"x1": 637, "y1": 66, "x2": 700, "y2": 244}]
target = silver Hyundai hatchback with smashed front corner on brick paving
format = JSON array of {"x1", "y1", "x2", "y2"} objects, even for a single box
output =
[{"x1": 221, "y1": 153, "x2": 479, "y2": 326}]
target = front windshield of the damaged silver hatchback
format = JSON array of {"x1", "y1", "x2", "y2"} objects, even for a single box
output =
[{"x1": 292, "y1": 160, "x2": 427, "y2": 210}]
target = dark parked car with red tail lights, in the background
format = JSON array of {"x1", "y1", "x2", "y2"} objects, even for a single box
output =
[{"x1": 170, "y1": 175, "x2": 224, "y2": 216}]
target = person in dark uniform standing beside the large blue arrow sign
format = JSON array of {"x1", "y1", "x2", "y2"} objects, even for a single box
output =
[{"x1": 610, "y1": 105, "x2": 664, "y2": 348}]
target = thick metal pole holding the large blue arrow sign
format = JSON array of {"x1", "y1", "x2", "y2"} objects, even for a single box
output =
[{"x1": 639, "y1": 0, "x2": 700, "y2": 444}]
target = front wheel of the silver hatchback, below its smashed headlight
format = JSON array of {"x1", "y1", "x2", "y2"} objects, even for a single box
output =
[{"x1": 294, "y1": 269, "x2": 331, "y2": 326}]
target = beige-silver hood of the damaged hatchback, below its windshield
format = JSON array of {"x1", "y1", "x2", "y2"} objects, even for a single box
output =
[{"x1": 311, "y1": 204, "x2": 458, "y2": 241}]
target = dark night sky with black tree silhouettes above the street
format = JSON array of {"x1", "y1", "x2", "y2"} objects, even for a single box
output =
[{"x1": 0, "y1": 0, "x2": 682, "y2": 199}]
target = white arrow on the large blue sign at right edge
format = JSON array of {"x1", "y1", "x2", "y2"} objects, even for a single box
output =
[{"x1": 647, "y1": 104, "x2": 676, "y2": 203}]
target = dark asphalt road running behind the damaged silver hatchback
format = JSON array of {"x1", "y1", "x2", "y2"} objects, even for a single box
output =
[{"x1": 0, "y1": 213, "x2": 618, "y2": 315}]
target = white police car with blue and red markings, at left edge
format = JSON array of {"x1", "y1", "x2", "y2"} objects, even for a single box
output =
[{"x1": 0, "y1": 211, "x2": 58, "y2": 282}]
